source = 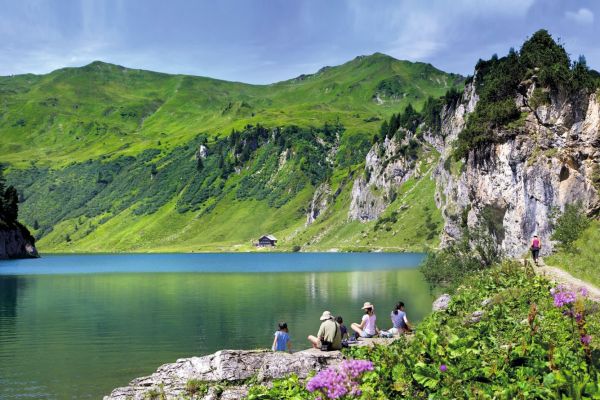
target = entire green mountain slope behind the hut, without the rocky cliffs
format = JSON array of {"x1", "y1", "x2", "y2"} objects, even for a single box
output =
[{"x1": 0, "y1": 53, "x2": 462, "y2": 251}]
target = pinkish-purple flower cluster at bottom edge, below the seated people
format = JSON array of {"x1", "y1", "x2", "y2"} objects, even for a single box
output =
[{"x1": 306, "y1": 360, "x2": 373, "y2": 399}]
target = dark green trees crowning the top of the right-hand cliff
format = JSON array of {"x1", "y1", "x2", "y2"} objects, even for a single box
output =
[{"x1": 454, "y1": 30, "x2": 600, "y2": 159}]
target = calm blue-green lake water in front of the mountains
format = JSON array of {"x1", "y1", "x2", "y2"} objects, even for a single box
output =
[{"x1": 0, "y1": 253, "x2": 432, "y2": 399}]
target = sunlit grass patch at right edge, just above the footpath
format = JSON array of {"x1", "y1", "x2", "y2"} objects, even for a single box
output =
[{"x1": 545, "y1": 220, "x2": 600, "y2": 287}]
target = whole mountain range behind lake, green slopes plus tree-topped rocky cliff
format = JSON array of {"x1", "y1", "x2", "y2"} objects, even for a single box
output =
[{"x1": 7, "y1": 31, "x2": 600, "y2": 254}]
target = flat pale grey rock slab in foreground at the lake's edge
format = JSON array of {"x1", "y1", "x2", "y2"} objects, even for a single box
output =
[{"x1": 104, "y1": 350, "x2": 343, "y2": 400}]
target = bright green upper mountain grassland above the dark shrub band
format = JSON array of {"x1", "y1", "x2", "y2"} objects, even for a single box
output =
[{"x1": 0, "y1": 54, "x2": 462, "y2": 168}]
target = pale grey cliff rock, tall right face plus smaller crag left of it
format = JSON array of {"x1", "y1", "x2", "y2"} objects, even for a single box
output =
[{"x1": 349, "y1": 55, "x2": 600, "y2": 256}]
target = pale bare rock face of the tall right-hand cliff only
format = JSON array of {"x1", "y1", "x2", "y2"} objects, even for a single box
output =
[{"x1": 435, "y1": 83, "x2": 600, "y2": 256}]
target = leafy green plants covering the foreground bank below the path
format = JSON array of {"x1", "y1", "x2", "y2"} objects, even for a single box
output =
[{"x1": 249, "y1": 262, "x2": 600, "y2": 399}]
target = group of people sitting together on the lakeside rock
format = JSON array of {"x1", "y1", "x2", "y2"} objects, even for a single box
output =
[{"x1": 272, "y1": 301, "x2": 412, "y2": 352}]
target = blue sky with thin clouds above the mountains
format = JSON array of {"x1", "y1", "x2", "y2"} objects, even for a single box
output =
[{"x1": 0, "y1": 0, "x2": 600, "y2": 84}]
